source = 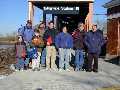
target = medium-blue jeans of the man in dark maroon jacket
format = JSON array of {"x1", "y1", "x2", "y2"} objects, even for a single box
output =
[{"x1": 75, "y1": 49, "x2": 84, "y2": 69}]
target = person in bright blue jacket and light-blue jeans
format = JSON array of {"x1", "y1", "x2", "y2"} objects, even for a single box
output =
[{"x1": 55, "y1": 26, "x2": 73, "y2": 71}]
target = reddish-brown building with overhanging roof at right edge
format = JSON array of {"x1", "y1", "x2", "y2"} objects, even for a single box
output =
[{"x1": 104, "y1": 0, "x2": 120, "y2": 56}]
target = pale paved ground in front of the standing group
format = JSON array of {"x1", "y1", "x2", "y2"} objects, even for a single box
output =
[{"x1": 0, "y1": 60, "x2": 120, "y2": 90}]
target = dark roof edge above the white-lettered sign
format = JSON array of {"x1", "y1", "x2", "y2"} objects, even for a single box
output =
[{"x1": 28, "y1": 0, "x2": 94, "y2": 9}]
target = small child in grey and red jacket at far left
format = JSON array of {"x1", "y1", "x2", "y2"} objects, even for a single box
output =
[{"x1": 15, "y1": 36, "x2": 26, "y2": 71}]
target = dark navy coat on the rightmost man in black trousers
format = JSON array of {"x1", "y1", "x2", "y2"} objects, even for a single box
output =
[{"x1": 85, "y1": 30, "x2": 104, "y2": 54}]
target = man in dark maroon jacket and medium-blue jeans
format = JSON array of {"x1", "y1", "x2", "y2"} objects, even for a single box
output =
[{"x1": 72, "y1": 23, "x2": 85, "y2": 71}]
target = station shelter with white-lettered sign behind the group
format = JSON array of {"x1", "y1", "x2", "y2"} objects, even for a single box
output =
[{"x1": 28, "y1": 0, "x2": 94, "y2": 32}]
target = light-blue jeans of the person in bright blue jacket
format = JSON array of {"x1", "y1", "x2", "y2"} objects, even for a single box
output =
[{"x1": 59, "y1": 48, "x2": 70, "y2": 69}]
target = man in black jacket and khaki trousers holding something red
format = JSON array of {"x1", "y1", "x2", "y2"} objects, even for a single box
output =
[{"x1": 44, "y1": 21, "x2": 57, "y2": 70}]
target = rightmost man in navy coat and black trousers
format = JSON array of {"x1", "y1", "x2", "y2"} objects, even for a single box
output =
[{"x1": 85, "y1": 25, "x2": 104, "y2": 72}]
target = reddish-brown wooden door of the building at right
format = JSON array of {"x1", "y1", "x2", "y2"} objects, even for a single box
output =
[{"x1": 107, "y1": 19, "x2": 118, "y2": 55}]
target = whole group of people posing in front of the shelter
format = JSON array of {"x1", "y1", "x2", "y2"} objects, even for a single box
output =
[{"x1": 15, "y1": 20, "x2": 104, "y2": 72}]
